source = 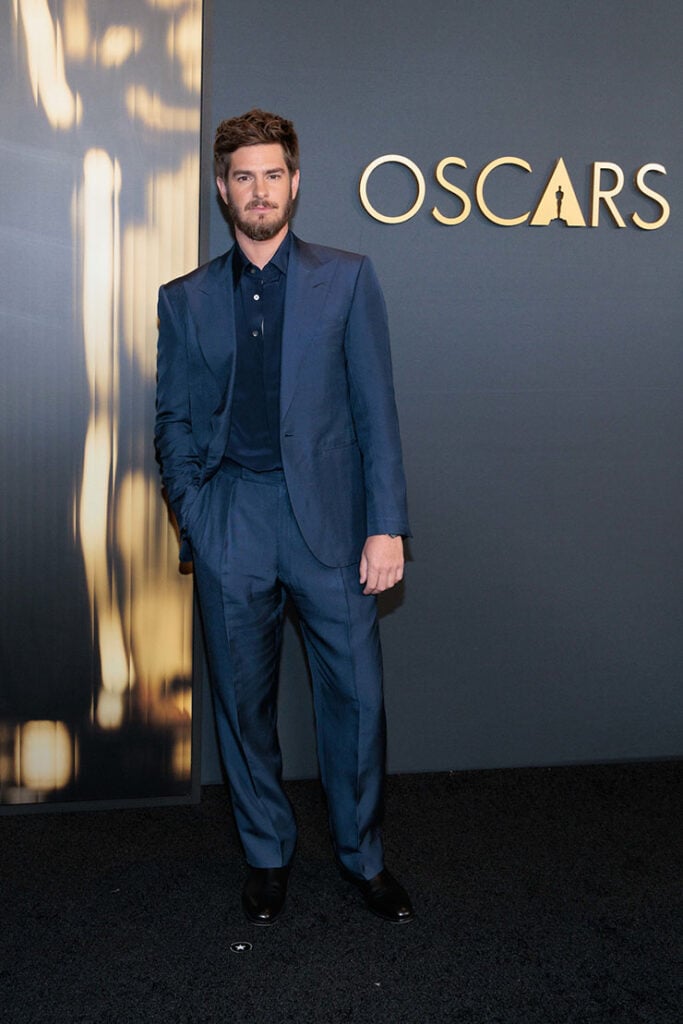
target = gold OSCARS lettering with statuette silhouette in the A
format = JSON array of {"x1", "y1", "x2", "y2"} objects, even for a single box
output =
[{"x1": 359, "y1": 154, "x2": 671, "y2": 231}]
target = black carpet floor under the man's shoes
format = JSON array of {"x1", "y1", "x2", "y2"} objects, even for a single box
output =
[{"x1": 0, "y1": 762, "x2": 683, "y2": 1024}]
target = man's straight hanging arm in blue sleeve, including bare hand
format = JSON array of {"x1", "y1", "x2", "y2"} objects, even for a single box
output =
[{"x1": 345, "y1": 257, "x2": 410, "y2": 594}]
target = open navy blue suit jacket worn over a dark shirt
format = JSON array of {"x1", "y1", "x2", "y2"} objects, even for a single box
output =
[{"x1": 156, "y1": 236, "x2": 410, "y2": 566}]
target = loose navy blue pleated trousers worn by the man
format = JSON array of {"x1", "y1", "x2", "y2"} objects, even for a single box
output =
[{"x1": 187, "y1": 462, "x2": 385, "y2": 879}]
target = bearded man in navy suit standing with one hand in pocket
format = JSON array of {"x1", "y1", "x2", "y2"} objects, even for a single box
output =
[{"x1": 156, "y1": 110, "x2": 413, "y2": 925}]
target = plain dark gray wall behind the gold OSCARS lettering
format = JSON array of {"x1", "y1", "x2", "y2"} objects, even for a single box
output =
[{"x1": 203, "y1": 0, "x2": 683, "y2": 781}]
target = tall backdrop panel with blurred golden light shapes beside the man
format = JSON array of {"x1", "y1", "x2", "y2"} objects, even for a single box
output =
[{"x1": 0, "y1": 0, "x2": 202, "y2": 813}]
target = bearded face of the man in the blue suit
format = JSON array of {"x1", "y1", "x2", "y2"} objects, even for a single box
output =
[{"x1": 216, "y1": 142, "x2": 299, "y2": 242}]
